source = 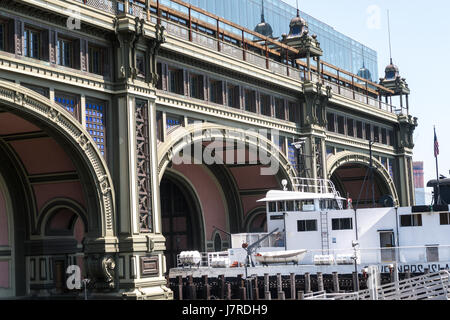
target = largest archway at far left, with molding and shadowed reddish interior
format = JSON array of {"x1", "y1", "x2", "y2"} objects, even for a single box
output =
[{"x1": 0, "y1": 81, "x2": 115, "y2": 297}]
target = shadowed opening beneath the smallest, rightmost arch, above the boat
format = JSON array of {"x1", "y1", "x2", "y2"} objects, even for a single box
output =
[{"x1": 331, "y1": 163, "x2": 392, "y2": 208}]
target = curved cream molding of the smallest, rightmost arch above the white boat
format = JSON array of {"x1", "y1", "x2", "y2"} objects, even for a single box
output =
[{"x1": 327, "y1": 151, "x2": 399, "y2": 206}]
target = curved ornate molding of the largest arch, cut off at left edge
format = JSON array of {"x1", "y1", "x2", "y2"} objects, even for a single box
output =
[{"x1": 0, "y1": 80, "x2": 115, "y2": 238}]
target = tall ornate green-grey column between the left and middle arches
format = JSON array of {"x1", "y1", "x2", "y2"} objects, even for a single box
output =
[{"x1": 112, "y1": 17, "x2": 172, "y2": 299}]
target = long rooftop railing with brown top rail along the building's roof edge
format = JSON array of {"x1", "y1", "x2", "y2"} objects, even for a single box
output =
[{"x1": 75, "y1": 0, "x2": 409, "y2": 114}]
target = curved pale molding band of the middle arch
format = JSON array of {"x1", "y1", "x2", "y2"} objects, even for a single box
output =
[{"x1": 158, "y1": 123, "x2": 296, "y2": 186}]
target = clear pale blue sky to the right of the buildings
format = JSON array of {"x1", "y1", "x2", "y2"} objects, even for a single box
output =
[{"x1": 284, "y1": 0, "x2": 450, "y2": 189}]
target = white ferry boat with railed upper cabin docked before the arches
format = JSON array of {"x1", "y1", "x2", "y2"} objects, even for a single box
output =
[{"x1": 169, "y1": 178, "x2": 450, "y2": 276}]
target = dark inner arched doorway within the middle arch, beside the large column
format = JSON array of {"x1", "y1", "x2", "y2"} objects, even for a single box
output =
[{"x1": 160, "y1": 173, "x2": 203, "y2": 269}]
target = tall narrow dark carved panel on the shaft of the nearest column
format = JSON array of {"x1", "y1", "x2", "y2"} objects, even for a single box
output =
[{"x1": 135, "y1": 101, "x2": 153, "y2": 232}]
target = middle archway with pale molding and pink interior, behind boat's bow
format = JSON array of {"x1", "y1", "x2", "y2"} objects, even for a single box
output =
[{"x1": 158, "y1": 123, "x2": 294, "y2": 269}]
